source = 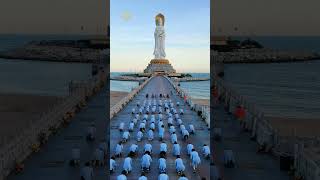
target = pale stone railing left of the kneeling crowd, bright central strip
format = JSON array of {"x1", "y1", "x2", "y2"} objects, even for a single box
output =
[{"x1": 110, "y1": 77, "x2": 153, "y2": 119}]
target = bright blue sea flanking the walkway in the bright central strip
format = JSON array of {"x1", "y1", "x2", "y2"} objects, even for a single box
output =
[{"x1": 110, "y1": 72, "x2": 210, "y2": 99}]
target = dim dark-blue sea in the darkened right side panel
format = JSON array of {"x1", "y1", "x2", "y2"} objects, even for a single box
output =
[{"x1": 225, "y1": 37, "x2": 320, "y2": 119}]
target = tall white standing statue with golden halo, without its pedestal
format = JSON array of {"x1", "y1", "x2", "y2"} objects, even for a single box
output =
[{"x1": 153, "y1": 14, "x2": 166, "y2": 59}]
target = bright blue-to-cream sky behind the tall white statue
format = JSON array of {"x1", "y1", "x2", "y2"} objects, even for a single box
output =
[{"x1": 110, "y1": 0, "x2": 210, "y2": 72}]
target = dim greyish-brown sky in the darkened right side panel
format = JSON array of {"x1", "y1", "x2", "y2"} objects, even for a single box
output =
[{"x1": 211, "y1": 0, "x2": 320, "y2": 35}]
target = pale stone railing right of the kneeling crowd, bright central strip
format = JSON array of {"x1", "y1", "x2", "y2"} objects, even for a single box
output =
[{"x1": 166, "y1": 77, "x2": 210, "y2": 128}]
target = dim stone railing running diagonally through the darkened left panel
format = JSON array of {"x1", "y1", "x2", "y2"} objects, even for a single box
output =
[{"x1": 0, "y1": 68, "x2": 107, "y2": 180}]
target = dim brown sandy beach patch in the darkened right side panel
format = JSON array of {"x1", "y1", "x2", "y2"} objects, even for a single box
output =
[{"x1": 266, "y1": 117, "x2": 320, "y2": 137}]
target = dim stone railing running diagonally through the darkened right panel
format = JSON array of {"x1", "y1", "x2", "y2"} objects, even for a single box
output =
[{"x1": 213, "y1": 77, "x2": 320, "y2": 180}]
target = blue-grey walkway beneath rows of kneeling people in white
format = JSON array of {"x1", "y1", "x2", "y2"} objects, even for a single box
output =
[{"x1": 110, "y1": 76, "x2": 210, "y2": 180}]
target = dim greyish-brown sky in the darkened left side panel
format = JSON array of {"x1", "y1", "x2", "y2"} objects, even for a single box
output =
[{"x1": 0, "y1": 0, "x2": 109, "y2": 34}]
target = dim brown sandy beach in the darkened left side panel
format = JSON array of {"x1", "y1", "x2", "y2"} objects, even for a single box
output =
[{"x1": 0, "y1": 94, "x2": 62, "y2": 144}]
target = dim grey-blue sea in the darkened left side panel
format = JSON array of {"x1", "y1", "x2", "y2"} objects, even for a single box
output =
[{"x1": 0, "y1": 35, "x2": 91, "y2": 96}]
